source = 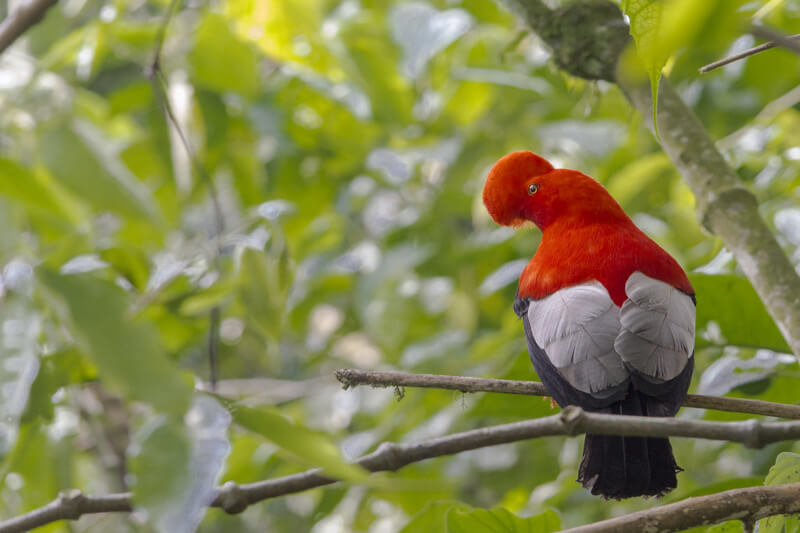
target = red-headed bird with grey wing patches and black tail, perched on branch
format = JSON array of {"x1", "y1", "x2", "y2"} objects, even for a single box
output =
[{"x1": 483, "y1": 152, "x2": 696, "y2": 499}]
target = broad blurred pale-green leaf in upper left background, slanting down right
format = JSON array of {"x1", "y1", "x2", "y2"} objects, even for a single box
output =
[{"x1": 41, "y1": 121, "x2": 156, "y2": 220}]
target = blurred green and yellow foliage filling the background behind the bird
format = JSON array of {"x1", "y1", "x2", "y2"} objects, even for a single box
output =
[{"x1": 0, "y1": 0, "x2": 800, "y2": 533}]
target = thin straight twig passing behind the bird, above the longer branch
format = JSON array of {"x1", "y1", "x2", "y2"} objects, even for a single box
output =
[{"x1": 336, "y1": 368, "x2": 800, "y2": 420}]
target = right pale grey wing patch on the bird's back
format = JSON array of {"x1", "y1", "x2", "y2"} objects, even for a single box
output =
[{"x1": 614, "y1": 272, "x2": 695, "y2": 383}]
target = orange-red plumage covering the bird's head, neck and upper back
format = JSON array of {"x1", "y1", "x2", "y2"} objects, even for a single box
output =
[{"x1": 483, "y1": 152, "x2": 694, "y2": 305}]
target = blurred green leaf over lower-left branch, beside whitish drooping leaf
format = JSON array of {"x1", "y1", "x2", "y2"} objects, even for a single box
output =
[{"x1": 133, "y1": 417, "x2": 191, "y2": 508}]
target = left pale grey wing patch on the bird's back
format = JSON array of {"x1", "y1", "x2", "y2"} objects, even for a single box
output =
[{"x1": 528, "y1": 281, "x2": 629, "y2": 396}]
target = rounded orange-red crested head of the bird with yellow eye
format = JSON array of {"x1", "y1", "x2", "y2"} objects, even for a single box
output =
[{"x1": 483, "y1": 152, "x2": 630, "y2": 229}]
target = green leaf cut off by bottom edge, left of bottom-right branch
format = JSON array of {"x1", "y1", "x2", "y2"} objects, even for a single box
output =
[{"x1": 447, "y1": 507, "x2": 561, "y2": 533}]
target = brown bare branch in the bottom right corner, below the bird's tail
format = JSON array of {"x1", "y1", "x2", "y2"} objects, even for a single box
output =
[{"x1": 563, "y1": 483, "x2": 800, "y2": 533}]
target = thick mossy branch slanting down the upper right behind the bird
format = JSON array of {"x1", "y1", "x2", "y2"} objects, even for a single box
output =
[{"x1": 503, "y1": 0, "x2": 800, "y2": 358}]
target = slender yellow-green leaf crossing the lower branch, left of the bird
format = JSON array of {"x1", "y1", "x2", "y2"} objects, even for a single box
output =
[{"x1": 218, "y1": 397, "x2": 369, "y2": 482}]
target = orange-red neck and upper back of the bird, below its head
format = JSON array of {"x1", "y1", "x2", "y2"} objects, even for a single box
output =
[{"x1": 518, "y1": 216, "x2": 694, "y2": 305}]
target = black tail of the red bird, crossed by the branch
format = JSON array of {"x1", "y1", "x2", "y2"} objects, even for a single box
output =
[{"x1": 578, "y1": 391, "x2": 682, "y2": 500}]
